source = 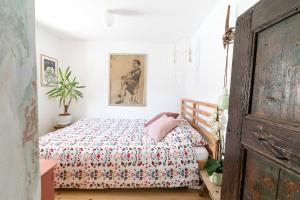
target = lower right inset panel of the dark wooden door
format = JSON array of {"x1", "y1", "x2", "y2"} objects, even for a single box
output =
[{"x1": 277, "y1": 170, "x2": 300, "y2": 200}]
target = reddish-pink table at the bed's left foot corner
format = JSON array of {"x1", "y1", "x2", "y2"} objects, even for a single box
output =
[{"x1": 40, "y1": 159, "x2": 57, "y2": 200}]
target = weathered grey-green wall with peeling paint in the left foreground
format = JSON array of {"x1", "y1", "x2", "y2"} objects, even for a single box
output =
[{"x1": 0, "y1": 0, "x2": 40, "y2": 200}]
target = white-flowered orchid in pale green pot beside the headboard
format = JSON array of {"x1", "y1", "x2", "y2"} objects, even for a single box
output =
[{"x1": 204, "y1": 107, "x2": 226, "y2": 185}]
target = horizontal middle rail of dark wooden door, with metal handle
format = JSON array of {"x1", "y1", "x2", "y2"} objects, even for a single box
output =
[{"x1": 242, "y1": 115, "x2": 300, "y2": 173}]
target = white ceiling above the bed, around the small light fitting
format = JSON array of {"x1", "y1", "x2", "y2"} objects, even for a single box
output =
[{"x1": 36, "y1": 0, "x2": 220, "y2": 43}]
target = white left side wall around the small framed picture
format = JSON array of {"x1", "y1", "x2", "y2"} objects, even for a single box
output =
[{"x1": 36, "y1": 27, "x2": 62, "y2": 135}]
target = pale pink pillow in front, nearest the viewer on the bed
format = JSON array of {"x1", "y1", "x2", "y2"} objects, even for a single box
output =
[{"x1": 145, "y1": 115, "x2": 180, "y2": 142}]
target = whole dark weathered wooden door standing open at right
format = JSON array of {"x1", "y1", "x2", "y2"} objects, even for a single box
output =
[{"x1": 221, "y1": 0, "x2": 300, "y2": 200}]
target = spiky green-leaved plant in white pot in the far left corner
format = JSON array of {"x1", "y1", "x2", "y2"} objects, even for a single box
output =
[{"x1": 47, "y1": 67, "x2": 85, "y2": 125}]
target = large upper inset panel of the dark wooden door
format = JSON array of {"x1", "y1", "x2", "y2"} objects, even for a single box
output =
[{"x1": 252, "y1": 13, "x2": 300, "y2": 122}]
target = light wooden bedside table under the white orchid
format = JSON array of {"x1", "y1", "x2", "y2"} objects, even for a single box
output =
[{"x1": 199, "y1": 170, "x2": 221, "y2": 200}]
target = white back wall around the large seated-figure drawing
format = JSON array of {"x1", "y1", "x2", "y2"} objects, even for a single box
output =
[{"x1": 63, "y1": 41, "x2": 182, "y2": 122}]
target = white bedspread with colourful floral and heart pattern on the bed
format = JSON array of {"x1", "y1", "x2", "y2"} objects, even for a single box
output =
[{"x1": 40, "y1": 119, "x2": 199, "y2": 189}]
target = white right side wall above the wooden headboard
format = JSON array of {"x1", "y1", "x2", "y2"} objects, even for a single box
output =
[{"x1": 185, "y1": 0, "x2": 258, "y2": 103}]
